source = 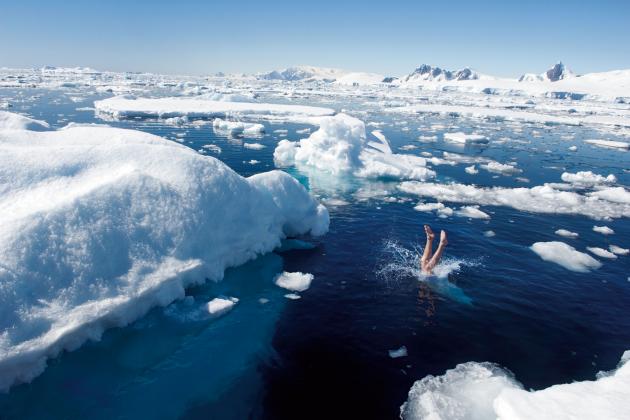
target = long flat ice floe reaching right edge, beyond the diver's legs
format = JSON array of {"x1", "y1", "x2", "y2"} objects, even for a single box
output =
[{"x1": 398, "y1": 181, "x2": 630, "y2": 219}]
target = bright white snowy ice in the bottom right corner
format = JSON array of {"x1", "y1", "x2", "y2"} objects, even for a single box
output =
[{"x1": 400, "y1": 351, "x2": 630, "y2": 420}]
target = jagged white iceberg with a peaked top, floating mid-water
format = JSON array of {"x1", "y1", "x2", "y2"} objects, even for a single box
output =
[{"x1": 274, "y1": 114, "x2": 435, "y2": 181}]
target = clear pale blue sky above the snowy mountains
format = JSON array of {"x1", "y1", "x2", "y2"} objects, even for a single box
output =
[{"x1": 0, "y1": 0, "x2": 630, "y2": 76}]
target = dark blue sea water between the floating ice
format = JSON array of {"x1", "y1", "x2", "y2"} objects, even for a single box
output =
[{"x1": 0, "y1": 90, "x2": 630, "y2": 419}]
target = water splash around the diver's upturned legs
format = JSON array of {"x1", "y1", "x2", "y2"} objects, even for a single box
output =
[{"x1": 376, "y1": 240, "x2": 479, "y2": 305}]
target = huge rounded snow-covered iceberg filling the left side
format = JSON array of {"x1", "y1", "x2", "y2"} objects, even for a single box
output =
[{"x1": 0, "y1": 126, "x2": 329, "y2": 389}]
